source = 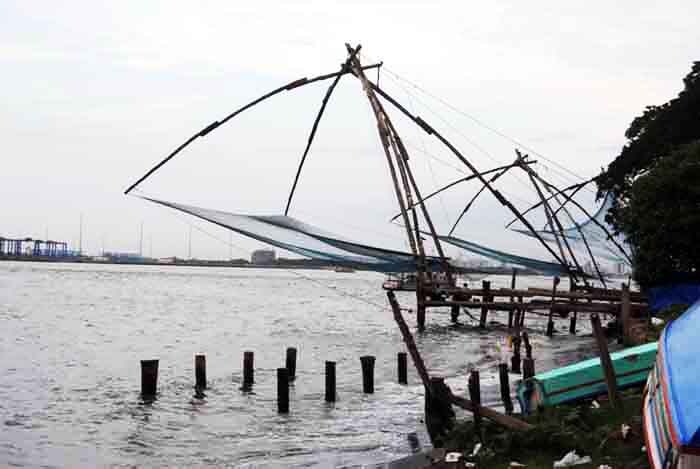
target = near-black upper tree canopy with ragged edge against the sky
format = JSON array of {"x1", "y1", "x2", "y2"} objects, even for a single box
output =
[{"x1": 597, "y1": 62, "x2": 700, "y2": 231}]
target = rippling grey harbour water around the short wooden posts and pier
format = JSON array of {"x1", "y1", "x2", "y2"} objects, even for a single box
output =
[{"x1": 0, "y1": 262, "x2": 612, "y2": 467}]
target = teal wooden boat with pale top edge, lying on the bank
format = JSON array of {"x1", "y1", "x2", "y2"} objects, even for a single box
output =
[{"x1": 517, "y1": 342, "x2": 657, "y2": 414}]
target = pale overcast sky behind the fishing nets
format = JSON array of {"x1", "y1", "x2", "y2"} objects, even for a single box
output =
[{"x1": 0, "y1": 0, "x2": 700, "y2": 258}]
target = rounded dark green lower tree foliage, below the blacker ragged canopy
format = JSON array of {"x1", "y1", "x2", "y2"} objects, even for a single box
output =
[{"x1": 617, "y1": 141, "x2": 700, "y2": 286}]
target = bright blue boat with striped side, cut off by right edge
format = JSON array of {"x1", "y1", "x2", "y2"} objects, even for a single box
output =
[{"x1": 642, "y1": 301, "x2": 700, "y2": 469}]
